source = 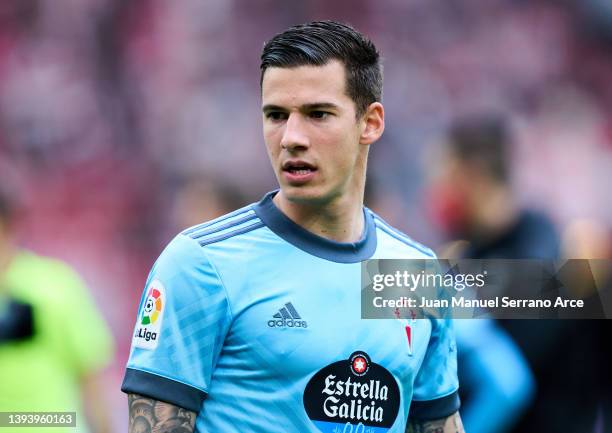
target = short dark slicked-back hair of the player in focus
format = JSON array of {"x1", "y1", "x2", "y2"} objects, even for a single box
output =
[{"x1": 260, "y1": 21, "x2": 383, "y2": 117}]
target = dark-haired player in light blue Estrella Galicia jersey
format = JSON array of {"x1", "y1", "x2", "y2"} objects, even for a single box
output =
[{"x1": 122, "y1": 22, "x2": 463, "y2": 433}]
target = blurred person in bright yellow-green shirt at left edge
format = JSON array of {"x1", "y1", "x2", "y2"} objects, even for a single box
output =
[{"x1": 0, "y1": 188, "x2": 113, "y2": 433}]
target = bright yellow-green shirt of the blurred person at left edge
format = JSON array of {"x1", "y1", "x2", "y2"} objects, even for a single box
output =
[{"x1": 0, "y1": 251, "x2": 113, "y2": 433}]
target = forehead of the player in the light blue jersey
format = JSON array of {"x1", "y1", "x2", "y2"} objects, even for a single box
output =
[{"x1": 261, "y1": 60, "x2": 351, "y2": 107}]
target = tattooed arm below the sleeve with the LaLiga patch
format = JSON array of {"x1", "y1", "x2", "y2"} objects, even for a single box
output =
[{"x1": 128, "y1": 394, "x2": 196, "y2": 433}]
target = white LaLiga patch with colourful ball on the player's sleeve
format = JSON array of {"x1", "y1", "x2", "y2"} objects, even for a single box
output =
[{"x1": 133, "y1": 280, "x2": 166, "y2": 350}]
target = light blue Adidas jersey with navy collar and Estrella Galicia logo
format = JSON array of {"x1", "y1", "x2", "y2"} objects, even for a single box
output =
[{"x1": 122, "y1": 193, "x2": 459, "y2": 433}]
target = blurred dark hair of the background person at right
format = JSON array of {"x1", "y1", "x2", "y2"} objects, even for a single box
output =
[{"x1": 448, "y1": 113, "x2": 512, "y2": 183}]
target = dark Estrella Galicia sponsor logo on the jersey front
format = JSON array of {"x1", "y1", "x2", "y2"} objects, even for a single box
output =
[{"x1": 304, "y1": 351, "x2": 400, "y2": 433}]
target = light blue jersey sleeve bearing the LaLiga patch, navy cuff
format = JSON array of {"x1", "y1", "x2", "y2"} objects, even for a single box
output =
[{"x1": 121, "y1": 235, "x2": 231, "y2": 413}]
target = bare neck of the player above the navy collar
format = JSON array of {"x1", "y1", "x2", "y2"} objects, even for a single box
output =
[{"x1": 273, "y1": 190, "x2": 365, "y2": 242}]
